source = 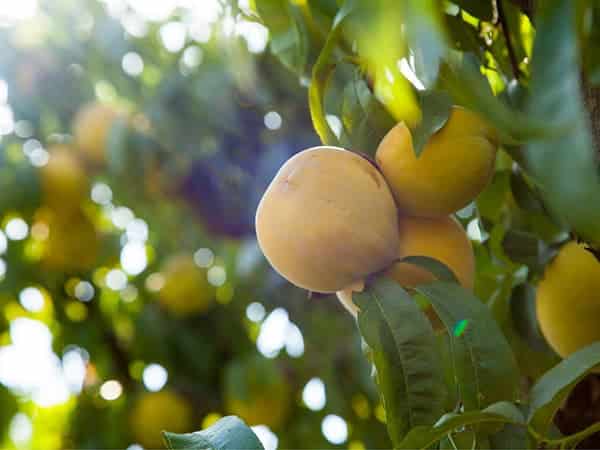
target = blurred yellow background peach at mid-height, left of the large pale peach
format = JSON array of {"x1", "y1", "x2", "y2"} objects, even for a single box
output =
[{"x1": 158, "y1": 253, "x2": 215, "y2": 317}]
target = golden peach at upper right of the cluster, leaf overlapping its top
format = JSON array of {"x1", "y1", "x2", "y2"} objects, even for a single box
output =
[{"x1": 375, "y1": 106, "x2": 497, "y2": 217}]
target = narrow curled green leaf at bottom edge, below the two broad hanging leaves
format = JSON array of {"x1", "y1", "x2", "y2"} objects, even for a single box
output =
[{"x1": 398, "y1": 402, "x2": 523, "y2": 449}]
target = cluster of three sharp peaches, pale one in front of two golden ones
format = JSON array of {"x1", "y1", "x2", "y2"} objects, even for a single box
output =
[{"x1": 256, "y1": 106, "x2": 497, "y2": 313}]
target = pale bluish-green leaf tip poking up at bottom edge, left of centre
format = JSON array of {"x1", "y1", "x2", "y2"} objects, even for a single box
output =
[{"x1": 163, "y1": 416, "x2": 264, "y2": 450}]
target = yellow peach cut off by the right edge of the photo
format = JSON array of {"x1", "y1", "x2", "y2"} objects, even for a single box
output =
[{"x1": 536, "y1": 242, "x2": 600, "y2": 358}]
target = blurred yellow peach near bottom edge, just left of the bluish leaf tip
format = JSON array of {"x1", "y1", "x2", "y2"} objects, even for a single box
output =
[{"x1": 129, "y1": 390, "x2": 195, "y2": 449}]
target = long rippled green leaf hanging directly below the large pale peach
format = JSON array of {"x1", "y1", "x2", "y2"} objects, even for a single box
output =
[{"x1": 355, "y1": 278, "x2": 446, "y2": 444}]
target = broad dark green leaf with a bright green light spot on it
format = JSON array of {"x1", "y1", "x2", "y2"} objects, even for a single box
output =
[{"x1": 416, "y1": 281, "x2": 519, "y2": 411}]
